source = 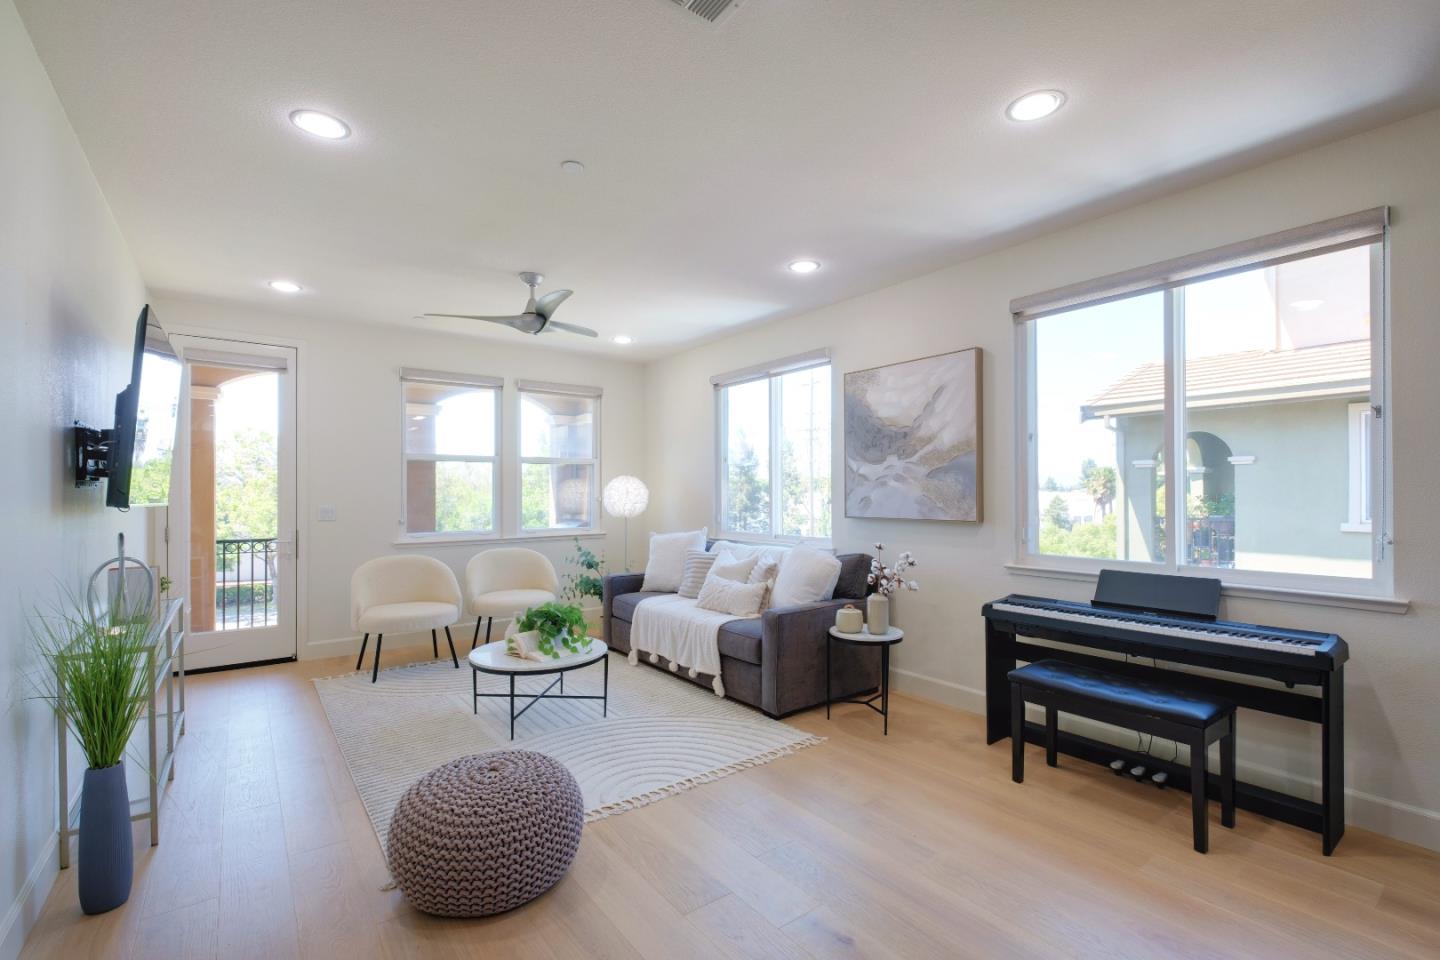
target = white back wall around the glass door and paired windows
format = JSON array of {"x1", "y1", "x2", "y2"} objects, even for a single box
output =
[{"x1": 156, "y1": 294, "x2": 644, "y2": 658}]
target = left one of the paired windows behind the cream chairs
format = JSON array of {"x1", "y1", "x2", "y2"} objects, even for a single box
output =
[{"x1": 400, "y1": 370, "x2": 501, "y2": 537}]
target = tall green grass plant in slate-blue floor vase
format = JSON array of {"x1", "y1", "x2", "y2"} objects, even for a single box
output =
[{"x1": 33, "y1": 597, "x2": 150, "y2": 914}]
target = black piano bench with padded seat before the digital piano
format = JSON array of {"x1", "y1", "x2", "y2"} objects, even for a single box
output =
[{"x1": 1008, "y1": 661, "x2": 1236, "y2": 853}]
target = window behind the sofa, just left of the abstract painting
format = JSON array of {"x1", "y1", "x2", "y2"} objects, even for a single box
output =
[{"x1": 711, "y1": 353, "x2": 831, "y2": 540}]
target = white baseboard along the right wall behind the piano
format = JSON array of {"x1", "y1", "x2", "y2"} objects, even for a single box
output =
[{"x1": 891, "y1": 668, "x2": 1440, "y2": 851}]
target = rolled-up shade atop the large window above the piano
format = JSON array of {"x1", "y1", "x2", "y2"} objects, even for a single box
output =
[{"x1": 1009, "y1": 207, "x2": 1390, "y2": 321}]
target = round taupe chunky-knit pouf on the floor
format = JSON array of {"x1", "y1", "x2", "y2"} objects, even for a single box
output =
[{"x1": 386, "y1": 750, "x2": 585, "y2": 917}]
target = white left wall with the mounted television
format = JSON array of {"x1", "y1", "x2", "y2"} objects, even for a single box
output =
[{"x1": 0, "y1": 0, "x2": 147, "y2": 957}]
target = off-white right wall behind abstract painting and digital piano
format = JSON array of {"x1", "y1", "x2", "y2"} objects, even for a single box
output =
[{"x1": 644, "y1": 112, "x2": 1440, "y2": 849}]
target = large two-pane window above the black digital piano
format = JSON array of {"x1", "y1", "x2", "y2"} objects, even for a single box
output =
[{"x1": 1012, "y1": 210, "x2": 1385, "y2": 586}]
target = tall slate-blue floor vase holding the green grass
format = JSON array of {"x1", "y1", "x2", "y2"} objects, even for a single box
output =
[{"x1": 79, "y1": 761, "x2": 135, "y2": 914}]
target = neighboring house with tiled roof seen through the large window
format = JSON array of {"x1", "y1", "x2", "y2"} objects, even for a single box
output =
[{"x1": 1082, "y1": 338, "x2": 1372, "y2": 576}]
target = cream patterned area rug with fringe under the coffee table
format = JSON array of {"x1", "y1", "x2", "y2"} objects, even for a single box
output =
[{"x1": 314, "y1": 653, "x2": 822, "y2": 848}]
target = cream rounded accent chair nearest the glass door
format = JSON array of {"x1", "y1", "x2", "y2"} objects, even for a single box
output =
[{"x1": 350, "y1": 554, "x2": 461, "y2": 684}]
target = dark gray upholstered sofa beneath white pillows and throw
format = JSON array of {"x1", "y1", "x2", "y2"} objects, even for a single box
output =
[{"x1": 602, "y1": 553, "x2": 880, "y2": 718}]
